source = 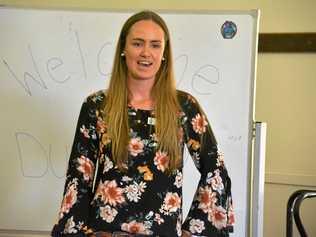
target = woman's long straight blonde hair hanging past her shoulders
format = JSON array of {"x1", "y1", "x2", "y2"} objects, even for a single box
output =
[{"x1": 104, "y1": 11, "x2": 181, "y2": 172}]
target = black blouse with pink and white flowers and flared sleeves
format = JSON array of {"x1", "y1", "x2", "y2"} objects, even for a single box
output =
[{"x1": 52, "y1": 91, "x2": 234, "y2": 237}]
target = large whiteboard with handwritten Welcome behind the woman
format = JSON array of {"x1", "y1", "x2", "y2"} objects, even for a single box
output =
[{"x1": 0, "y1": 8, "x2": 258, "y2": 236}]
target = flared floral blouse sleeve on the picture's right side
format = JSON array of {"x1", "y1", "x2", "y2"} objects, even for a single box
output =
[{"x1": 182, "y1": 94, "x2": 234, "y2": 236}]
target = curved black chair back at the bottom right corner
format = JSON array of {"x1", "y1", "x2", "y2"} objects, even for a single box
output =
[{"x1": 286, "y1": 189, "x2": 316, "y2": 237}]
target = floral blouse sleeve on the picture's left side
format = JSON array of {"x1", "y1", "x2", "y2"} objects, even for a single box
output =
[{"x1": 51, "y1": 96, "x2": 99, "y2": 237}]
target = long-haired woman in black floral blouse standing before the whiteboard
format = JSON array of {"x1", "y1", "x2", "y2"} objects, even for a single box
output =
[{"x1": 52, "y1": 11, "x2": 234, "y2": 237}]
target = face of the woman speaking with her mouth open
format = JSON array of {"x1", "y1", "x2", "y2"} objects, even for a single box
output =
[{"x1": 124, "y1": 20, "x2": 165, "y2": 84}]
